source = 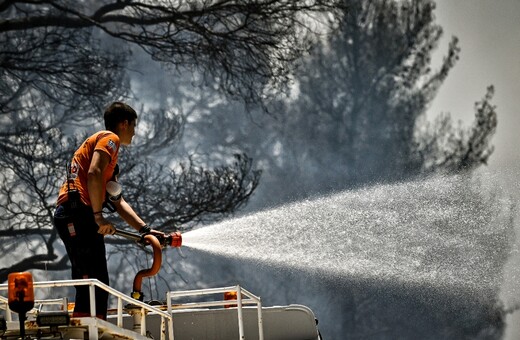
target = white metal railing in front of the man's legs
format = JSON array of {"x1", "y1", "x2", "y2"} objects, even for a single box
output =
[{"x1": 0, "y1": 279, "x2": 173, "y2": 340}]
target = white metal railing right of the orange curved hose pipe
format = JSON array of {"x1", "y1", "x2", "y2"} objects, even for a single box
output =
[{"x1": 166, "y1": 285, "x2": 264, "y2": 340}]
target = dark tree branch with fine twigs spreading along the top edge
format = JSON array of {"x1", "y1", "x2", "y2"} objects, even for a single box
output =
[{"x1": 0, "y1": 0, "x2": 341, "y2": 102}]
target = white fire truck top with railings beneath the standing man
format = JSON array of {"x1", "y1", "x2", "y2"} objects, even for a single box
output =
[{"x1": 0, "y1": 279, "x2": 321, "y2": 340}]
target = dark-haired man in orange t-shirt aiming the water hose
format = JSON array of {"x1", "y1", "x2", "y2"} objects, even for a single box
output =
[{"x1": 54, "y1": 102, "x2": 164, "y2": 319}]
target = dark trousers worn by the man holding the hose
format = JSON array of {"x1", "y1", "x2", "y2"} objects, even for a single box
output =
[{"x1": 54, "y1": 204, "x2": 109, "y2": 319}]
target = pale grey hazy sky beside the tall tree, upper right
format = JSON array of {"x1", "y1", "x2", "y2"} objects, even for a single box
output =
[{"x1": 429, "y1": 0, "x2": 520, "y2": 169}]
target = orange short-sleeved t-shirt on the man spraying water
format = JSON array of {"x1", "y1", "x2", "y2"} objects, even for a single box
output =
[{"x1": 56, "y1": 131, "x2": 120, "y2": 205}]
